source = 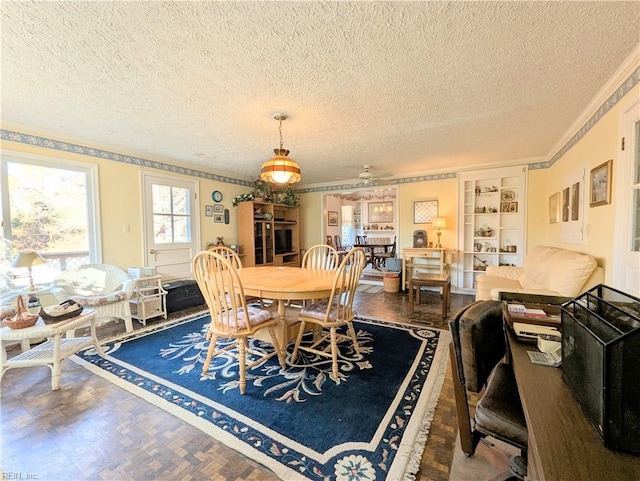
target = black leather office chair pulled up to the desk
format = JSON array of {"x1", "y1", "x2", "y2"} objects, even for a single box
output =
[{"x1": 449, "y1": 301, "x2": 528, "y2": 479}]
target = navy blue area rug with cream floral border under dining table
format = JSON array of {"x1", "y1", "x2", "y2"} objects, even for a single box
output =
[{"x1": 74, "y1": 316, "x2": 449, "y2": 481}]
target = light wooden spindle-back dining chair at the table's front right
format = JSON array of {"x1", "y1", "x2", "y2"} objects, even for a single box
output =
[{"x1": 291, "y1": 247, "x2": 366, "y2": 383}]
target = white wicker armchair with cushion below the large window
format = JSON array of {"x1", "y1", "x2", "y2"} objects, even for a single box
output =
[{"x1": 51, "y1": 264, "x2": 135, "y2": 335}]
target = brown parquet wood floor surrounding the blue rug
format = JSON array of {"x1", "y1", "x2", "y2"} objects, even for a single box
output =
[{"x1": 0, "y1": 286, "x2": 472, "y2": 481}]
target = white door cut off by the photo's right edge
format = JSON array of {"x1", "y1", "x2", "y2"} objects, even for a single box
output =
[{"x1": 613, "y1": 101, "x2": 640, "y2": 296}]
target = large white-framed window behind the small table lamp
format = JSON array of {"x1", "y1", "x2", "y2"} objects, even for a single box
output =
[{"x1": 0, "y1": 152, "x2": 102, "y2": 288}]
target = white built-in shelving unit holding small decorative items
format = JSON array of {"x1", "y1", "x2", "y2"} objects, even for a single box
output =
[{"x1": 458, "y1": 167, "x2": 527, "y2": 293}]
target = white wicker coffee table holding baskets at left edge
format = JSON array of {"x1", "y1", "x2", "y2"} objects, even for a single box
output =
[{"x1": 0, "y1": 309, "x2": 104, "y2": 391}]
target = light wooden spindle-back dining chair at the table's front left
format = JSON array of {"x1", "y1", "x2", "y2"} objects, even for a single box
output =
[{"x1": 193, "y1": 251, "x2": 286, "y2": 394}]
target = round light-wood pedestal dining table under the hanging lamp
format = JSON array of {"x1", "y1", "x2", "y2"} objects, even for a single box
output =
[{"x1": 238, "y1": 265, "x2": 336, "y2": 348}]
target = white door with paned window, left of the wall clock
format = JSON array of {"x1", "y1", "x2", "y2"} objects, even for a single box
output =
[{"x1": 142, "y1": 173, "x2": 199, "y2": 282}]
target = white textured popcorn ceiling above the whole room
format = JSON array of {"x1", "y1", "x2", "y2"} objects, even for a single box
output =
[{"x1": 1, "y1": 0, "x2": 640, "y2": 184}]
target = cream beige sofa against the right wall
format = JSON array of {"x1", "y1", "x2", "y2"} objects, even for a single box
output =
[{"x1": 476, "y1": 246, "x2": 604, "y2": 300}]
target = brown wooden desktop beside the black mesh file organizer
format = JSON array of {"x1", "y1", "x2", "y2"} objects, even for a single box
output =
[{"x1": 506, "y1": 329, "x2": 640, "y2": 481}]
